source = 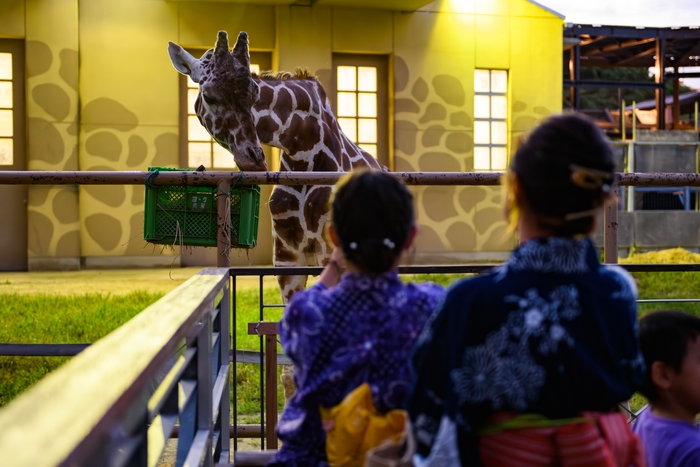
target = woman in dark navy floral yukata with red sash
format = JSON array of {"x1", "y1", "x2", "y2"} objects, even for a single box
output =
[{"x1": 409, "y1": 114, "x2": 644, "y2": 467}]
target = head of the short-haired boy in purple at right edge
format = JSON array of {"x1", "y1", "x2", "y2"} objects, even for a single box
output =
[{"x1": 639, "y1": 310, "x2": 700, "y2": 414}]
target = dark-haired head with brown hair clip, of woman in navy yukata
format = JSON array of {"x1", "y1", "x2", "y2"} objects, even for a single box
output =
[{"x1": 507, "y1": 114, "x2": 615, "y2": 237}]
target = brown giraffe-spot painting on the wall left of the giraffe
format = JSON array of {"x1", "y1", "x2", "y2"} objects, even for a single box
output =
[{"x1": 27, "y1": 41, "x2": 178, "y2": 268}]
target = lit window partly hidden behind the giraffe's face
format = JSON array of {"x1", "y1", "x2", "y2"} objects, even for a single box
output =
[{"x1": 185, "y1": 63, "x2": 260, "y2": 169}]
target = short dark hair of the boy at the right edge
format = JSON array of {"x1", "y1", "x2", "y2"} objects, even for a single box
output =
[{"x1": 639, "y1": 310, "x2": 700, "y2": 402}]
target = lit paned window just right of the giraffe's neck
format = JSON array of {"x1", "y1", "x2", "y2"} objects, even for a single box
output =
[{"x1": 336, "y1": 65, "x2": 378, "y2": 157}]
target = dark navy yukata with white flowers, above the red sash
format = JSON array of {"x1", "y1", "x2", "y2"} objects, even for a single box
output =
[{"x1": 408, "y1": 238, "x2": 644, "y2": 466}]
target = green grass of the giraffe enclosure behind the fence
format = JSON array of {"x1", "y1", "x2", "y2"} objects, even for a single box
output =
[{"x1": 0, "y1": 266, "x2": 700, "y2": 423}]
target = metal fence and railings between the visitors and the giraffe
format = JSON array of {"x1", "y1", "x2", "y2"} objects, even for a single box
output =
[{"x1": 0, "y1": 172, "x2": 700, "y2": 466}]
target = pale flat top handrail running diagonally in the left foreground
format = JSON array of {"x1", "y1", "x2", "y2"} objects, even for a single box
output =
[{"x1": 0, "y1": 268, "x2": 229, "y2": 467}]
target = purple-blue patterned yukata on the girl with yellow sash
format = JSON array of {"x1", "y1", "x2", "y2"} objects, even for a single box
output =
[{"x1": 270, "y1": 272, "x2": 444, "y2": 467}]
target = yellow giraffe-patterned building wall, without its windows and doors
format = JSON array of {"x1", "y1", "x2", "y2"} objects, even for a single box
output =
[{"x1": 0, "y1": 0, "x2": 562, "y2": 269}]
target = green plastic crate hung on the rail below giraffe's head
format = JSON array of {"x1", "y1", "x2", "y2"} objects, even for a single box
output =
[{"x1": 143, "y1": 167, "x2": 260, "y2": 248}]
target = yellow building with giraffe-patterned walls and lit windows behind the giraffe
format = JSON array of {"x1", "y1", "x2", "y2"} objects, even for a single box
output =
[{"x1": 0, "y1": 0, "x2": 562, "y2": 270}]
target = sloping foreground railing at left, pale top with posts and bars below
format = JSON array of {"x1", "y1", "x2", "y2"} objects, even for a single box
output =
[{"x1": 0, "y1": 269, "x2": 230, "y2": 467}]
